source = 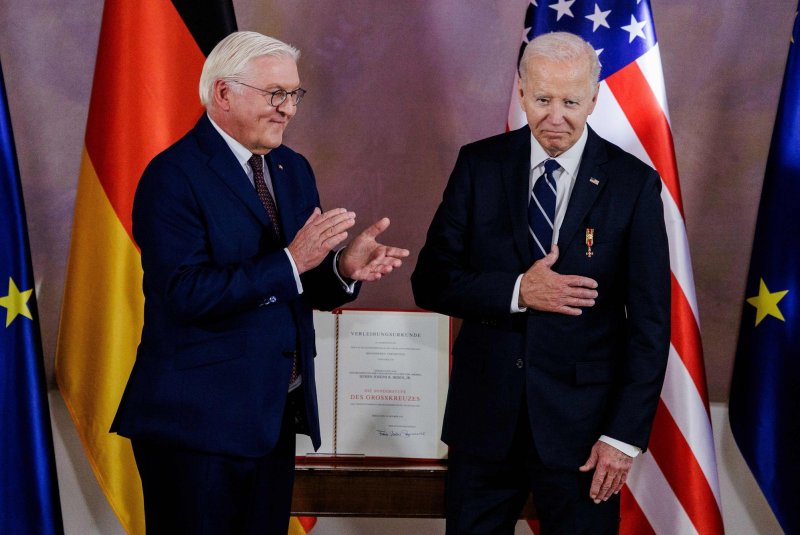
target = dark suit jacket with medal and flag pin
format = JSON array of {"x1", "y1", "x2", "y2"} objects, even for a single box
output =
[{"x1": 412, "y1": 126, "x2": 670, "y2": 469}]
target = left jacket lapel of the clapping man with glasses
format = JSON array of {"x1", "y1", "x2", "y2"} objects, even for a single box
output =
[{"x1": 194, "y1": 114, "x2": 270, "y2": 226}]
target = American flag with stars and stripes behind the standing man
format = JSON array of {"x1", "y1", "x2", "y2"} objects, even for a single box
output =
[{"x1": 508, "y1": 0, "x2": 723, "y2": 535}]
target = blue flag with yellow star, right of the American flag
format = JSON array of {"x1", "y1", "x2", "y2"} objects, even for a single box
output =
[{"x1": 730, "y1": 5, "x2": 800, "y2": 534}]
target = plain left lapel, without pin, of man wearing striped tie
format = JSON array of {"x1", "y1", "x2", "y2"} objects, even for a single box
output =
[{"x1": 500, "y1": 126, "x2": 532, "y2": 266}]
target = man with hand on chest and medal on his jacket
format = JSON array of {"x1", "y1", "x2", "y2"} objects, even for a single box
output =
[{"x1": 412, "y1": 33, "x2": 670, "y2": 534}]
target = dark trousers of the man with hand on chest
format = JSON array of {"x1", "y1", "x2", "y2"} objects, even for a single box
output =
[{"x1": 446, "y1": 409, "x2": 619, "y2": 535}]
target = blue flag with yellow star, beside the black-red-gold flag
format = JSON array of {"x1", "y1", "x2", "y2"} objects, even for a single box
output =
[{"x1": 0, "y1": 59, "x2": 64, "y2": 534}]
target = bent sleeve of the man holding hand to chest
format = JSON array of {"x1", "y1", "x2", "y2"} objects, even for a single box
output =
[{"x1": 411, "y1": 148, "x2": 520, "y2": 319}]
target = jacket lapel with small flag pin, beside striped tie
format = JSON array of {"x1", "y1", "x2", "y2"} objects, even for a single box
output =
[{"x1": 558, "y1": 129, "x2": 608, "y2": 251}]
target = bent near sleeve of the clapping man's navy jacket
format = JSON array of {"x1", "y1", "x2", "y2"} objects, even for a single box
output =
[{"x1": 133, "y1": 155, "x2": 298, "y2": 322}]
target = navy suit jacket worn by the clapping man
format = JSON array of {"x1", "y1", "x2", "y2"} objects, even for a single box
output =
[{"x1": 112, "y1": 114, "x2": 355, "y2": 456}]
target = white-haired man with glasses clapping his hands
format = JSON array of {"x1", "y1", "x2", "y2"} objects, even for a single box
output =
[{"x1": 112, "y1": 32, "x2": 408, "y2": 534}]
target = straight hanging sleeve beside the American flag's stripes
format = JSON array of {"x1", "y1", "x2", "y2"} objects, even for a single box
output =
[{"x1": 605, "y1": 171, "x2": 671, "y2": 450}]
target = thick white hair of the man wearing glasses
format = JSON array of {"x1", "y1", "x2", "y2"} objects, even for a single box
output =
[{"x1": 199, "y1": 32, "x2": 300, "y2": 108}]
